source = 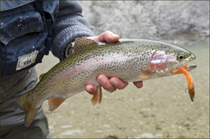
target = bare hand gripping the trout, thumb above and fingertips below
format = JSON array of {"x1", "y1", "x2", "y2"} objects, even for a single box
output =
[{"x1": 85, "y1": 31, "x2": 143, "y2": 95}]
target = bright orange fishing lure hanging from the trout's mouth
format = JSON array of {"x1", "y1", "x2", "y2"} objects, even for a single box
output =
[{"x1": 171, "y1": 65, "x2": 195, "y2": 101}]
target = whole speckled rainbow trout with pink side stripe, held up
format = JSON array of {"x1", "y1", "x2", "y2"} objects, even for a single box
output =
[{"x1": 16, "y1": 38, "x2": 196, "y2": 127}]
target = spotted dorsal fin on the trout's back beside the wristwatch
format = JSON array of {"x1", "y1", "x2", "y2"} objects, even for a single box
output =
[{"x1": 73, "y1": 38, "x2": 97, "y2": 52}]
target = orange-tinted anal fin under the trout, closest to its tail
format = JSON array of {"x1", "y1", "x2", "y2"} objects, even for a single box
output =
[{"x1": 48, "y1": 97, "x2": 66, "y2": 111}]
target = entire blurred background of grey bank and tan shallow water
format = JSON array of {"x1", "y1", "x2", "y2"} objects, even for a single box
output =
[{"x1": 36, "y1": 1, "x2": 209, "y2": 139}]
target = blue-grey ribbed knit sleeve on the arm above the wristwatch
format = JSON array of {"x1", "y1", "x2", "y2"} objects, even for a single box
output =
[{"x1": 51, "y1": 0, "x2": 94, "y2": 60}]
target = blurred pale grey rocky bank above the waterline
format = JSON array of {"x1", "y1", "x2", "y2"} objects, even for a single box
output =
[{"x1": 80, "y1": 0, "x2": 209, "y2": 43}]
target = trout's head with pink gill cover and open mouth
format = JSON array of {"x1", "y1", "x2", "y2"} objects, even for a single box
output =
[{"x1": 150, "y1": 45, "x2": 197, "y2": 76}]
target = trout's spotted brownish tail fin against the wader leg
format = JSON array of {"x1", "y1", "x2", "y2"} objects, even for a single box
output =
[{"x1": 16, "y1": 92, "x2": 39, "y2": 127}]
